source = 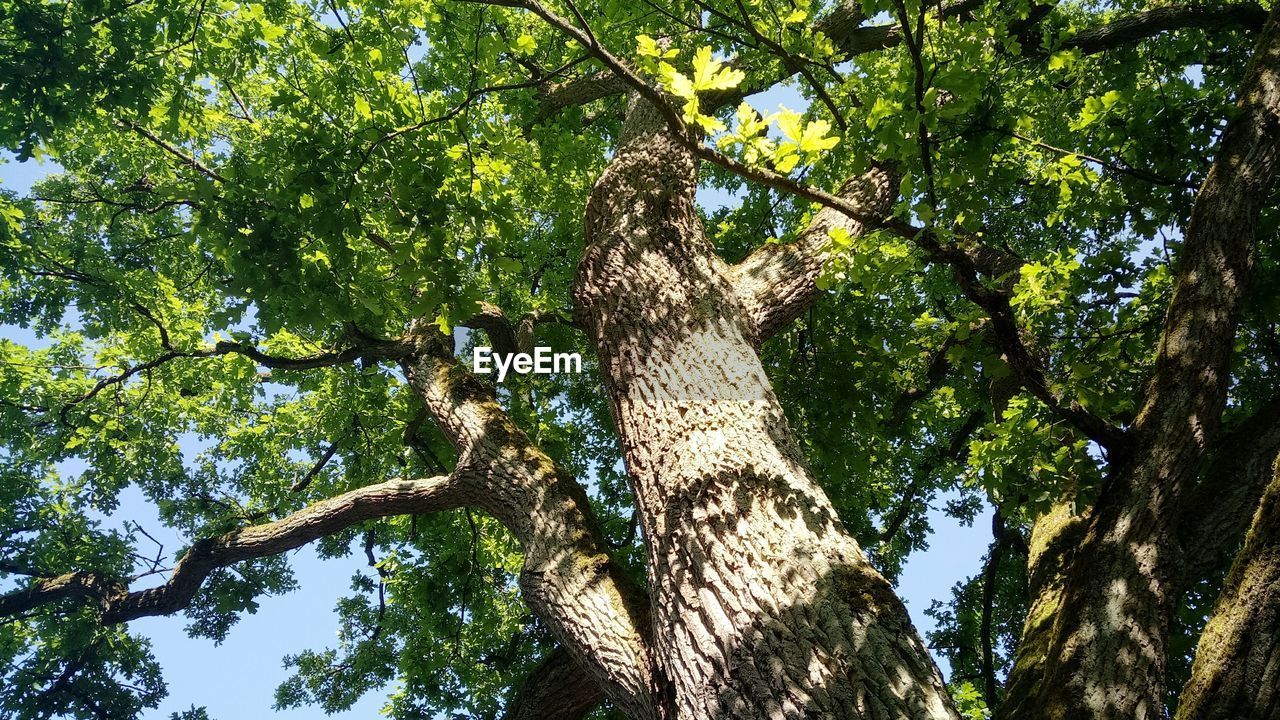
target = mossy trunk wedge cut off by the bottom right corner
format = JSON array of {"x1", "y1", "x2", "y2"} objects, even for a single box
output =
[{"x1": 1176, "y1": 456, "x2": 1280, "y2": 720}]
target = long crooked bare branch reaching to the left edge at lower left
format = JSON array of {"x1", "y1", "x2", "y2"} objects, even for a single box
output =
[{"x1": 0, "y1": 475, "x2": 470, "y2": 624}]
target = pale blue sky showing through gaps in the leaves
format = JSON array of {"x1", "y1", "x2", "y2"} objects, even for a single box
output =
[{"x1": 0, "y1": 137, "x2": 991, "y2": 720}]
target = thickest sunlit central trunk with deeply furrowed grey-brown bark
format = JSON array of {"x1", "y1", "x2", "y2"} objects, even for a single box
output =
[{"x1": 575, "y1": 94, "x2": 955, "y2": 720}]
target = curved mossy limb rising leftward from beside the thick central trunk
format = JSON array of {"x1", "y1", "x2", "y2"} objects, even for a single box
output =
[{"x1": 404, "y1": 333, "x2": 658, "y2": 719}]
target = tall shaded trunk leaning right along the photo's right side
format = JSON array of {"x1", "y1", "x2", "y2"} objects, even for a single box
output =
[{"x1": 1002, "y1": 4, "x2": 1280, "y2": 720}]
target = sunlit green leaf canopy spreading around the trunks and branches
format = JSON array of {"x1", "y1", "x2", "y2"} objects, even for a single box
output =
[{"x1": 0, "y1": 0, "x2": 1280, "y2": 719}]
